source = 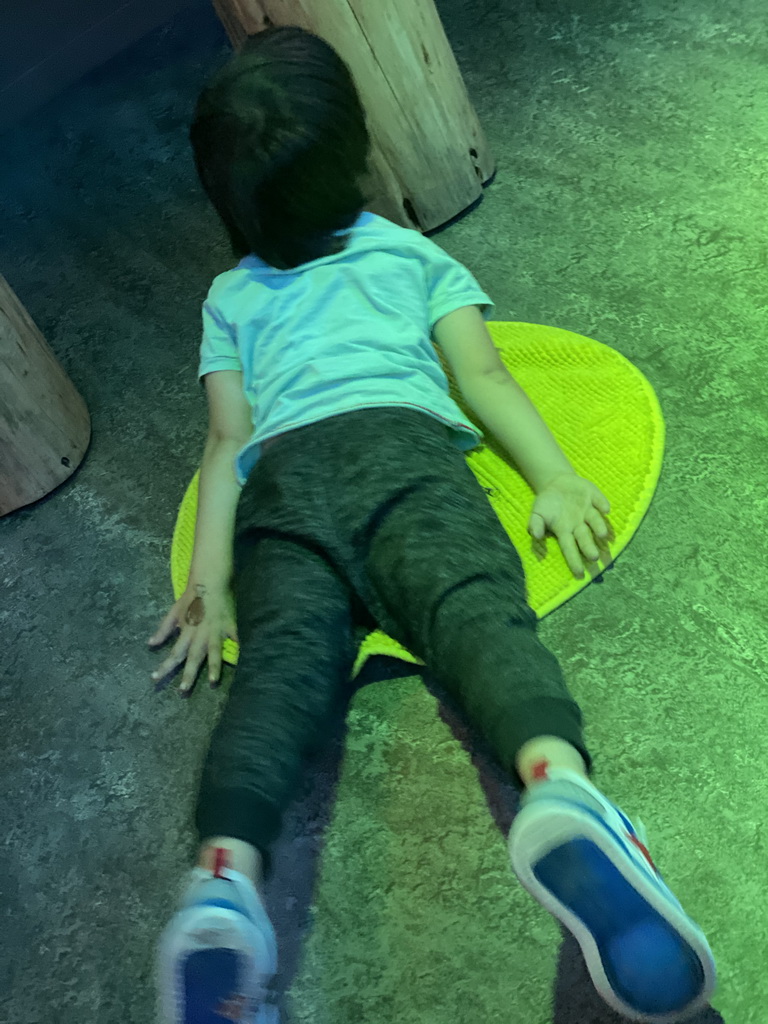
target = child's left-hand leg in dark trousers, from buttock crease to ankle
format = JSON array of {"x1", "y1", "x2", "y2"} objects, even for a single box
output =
[{"x1": 196, "y1": 536, "x2": 356, "y2": 891}]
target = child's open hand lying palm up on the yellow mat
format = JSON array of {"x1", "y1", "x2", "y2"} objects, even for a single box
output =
[{"x1": 528, "y1": 473, "x2": 612, "y2": 580}]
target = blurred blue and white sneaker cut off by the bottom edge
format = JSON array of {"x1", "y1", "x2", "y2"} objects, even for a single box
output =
[{"x1": 157, "y1": 850, "x2": 280, "y2": 1024}]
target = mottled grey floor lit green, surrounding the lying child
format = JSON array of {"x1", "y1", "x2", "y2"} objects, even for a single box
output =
[{"x1": 0, "y1": 0, "x2": 768, "y2": 1024}]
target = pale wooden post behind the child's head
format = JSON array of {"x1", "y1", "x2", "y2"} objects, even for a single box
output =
[{"x1": 213, "y1": 0, "x2": 496, "y2": 231}]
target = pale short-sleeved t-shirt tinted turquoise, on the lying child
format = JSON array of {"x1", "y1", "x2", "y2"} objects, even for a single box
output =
[{"x1": 198, "y1": 212, "x2": 494, "y2": 486}]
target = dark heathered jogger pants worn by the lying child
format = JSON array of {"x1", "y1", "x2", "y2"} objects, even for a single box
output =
[{"x1": 196, "y1": 407, "x2": 592, "y2": 878}]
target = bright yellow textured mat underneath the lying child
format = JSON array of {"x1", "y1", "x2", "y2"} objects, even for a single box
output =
[{"x1": 171, "y1": 322, "x2": 665, "y2": 678}]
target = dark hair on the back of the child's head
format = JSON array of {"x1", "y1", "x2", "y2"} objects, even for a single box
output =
[{"x1": 189, "y1": 26, "x2": 371, "y2": 269}]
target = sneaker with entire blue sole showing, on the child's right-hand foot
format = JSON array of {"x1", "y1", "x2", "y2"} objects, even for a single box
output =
[{"x1": 509, "y1": 769, "x2": 716, "y2": 1024}]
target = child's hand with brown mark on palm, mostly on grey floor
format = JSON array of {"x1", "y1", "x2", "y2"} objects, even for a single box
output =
[{"x1": 148, "y1": 586, "x2": 239, "y2": 696}]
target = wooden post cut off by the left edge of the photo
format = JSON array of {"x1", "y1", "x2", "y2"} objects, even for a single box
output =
[{"x1": 0, "y1": 275, "x2": 91, "y2": 516}]
